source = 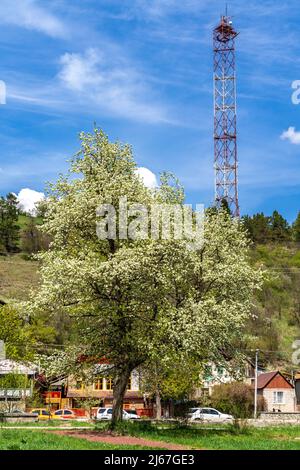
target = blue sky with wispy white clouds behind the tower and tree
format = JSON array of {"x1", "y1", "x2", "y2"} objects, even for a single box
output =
[{"x1": 0, "y1": 0, "x2": 300, "y2": 221}]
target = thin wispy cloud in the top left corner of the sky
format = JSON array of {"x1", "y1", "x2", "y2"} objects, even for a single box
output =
[{"x1": 0, "y1": 0, "x2": 66, "y2": 37}]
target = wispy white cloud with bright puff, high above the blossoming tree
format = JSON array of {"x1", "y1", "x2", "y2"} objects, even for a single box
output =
[{"x1": 58, "y1": 44, "x2": 174, "y2": 124}]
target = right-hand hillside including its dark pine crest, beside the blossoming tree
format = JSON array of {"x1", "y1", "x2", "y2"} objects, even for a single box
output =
[{"x1": 244, "y1": 211, "x2": 300, "y2": 368}]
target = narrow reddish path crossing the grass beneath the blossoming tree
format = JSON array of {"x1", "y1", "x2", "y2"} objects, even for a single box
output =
[{"x1": 50, "y1": 431, "x2": 189, "y2": 450}]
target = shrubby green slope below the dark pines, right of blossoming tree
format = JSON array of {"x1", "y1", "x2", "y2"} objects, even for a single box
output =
[{"x1": 249, "y1": 242, "x2": 300, "y2": 365}]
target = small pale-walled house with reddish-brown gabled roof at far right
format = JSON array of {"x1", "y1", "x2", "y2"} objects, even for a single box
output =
[{"x1": 252, "y1": 371, "x2": 296, "y2": 413}]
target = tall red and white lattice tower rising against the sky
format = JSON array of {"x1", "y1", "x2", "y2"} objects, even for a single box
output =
[{"x1": 213, "y1": 15, "x2": 240, "y2": 217}]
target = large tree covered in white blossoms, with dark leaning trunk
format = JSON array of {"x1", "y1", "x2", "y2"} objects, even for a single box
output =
[{"x1": 34, "y1": 129, "x2": 261, "y2": 424}]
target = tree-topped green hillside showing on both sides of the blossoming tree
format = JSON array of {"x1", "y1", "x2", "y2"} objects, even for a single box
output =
[{"x1": 0, "y1": 190, "x2": 300, "y2": 369}]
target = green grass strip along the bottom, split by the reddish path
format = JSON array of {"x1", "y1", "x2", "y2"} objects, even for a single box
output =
[{"x1": 0, "y1": 423, "x2": 300, "y2": 450}]
